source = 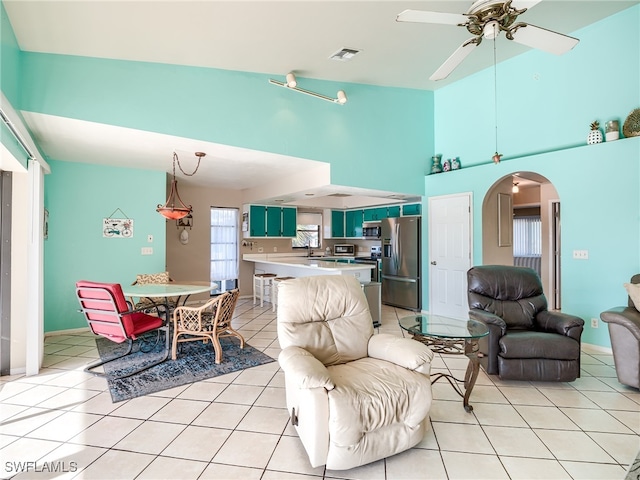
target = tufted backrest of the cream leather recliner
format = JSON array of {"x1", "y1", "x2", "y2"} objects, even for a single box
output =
[{"x1": 278, "y1": 275, "x2": 373, "y2": 366}]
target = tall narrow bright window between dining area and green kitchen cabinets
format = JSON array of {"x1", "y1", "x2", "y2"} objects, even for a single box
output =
[{"x1": 211, "y1": 207, "x2": 238, "y2": 293}]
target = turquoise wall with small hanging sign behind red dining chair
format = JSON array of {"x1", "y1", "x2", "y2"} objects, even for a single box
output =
[{"x1": 44, "y1": 160, "x2": 166, "y2": 332}]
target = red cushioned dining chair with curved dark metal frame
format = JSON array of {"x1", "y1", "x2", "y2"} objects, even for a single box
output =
[{"x1": 76, "y1": 280, "x2": 170, "y2": 378}]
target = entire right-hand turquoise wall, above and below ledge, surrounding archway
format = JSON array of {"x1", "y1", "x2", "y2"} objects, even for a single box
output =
[{"x1": 423, "y1": 6, "x2": 640, "y2": 347}]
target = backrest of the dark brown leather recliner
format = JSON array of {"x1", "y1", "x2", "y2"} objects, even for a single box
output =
[{"x1": 467, "y1": 265, "x2": 547, "y2": 329}]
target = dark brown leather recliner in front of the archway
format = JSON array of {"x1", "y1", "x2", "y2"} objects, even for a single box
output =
[{"x1": 467, "y1": 265, "x2": 584, "y2": 382}]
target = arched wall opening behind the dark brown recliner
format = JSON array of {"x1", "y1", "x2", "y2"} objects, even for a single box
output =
[{"x1": 482, "y1": 172, "x2": 561, "y2": 310}]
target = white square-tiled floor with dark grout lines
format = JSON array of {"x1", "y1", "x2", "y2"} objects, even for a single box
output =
[{"x1": 0, "y1": 299, "x2": 640, "y2": 480}]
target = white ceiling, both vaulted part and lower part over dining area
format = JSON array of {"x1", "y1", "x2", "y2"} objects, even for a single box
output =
[{"x1": 2, "y1": 0, "x2": 639, "y2": 206}]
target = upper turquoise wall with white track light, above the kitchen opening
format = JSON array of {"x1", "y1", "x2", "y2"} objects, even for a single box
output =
[{"x1": 21, "y1": 52, "x2": 434, "y2": 195}]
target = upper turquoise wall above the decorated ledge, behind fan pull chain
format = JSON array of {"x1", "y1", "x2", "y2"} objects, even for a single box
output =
[{"x1": 435, "y1": 6, "x2": 640, "y2": 166}]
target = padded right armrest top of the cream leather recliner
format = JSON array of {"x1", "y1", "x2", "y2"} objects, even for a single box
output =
[{"x1": 368, "y1": 333, "x2": 433, "y2": 375}]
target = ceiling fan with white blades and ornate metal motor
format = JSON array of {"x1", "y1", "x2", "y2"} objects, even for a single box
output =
[{"x1": 396, "y1": 0, "x2": 579, "y2": 80}]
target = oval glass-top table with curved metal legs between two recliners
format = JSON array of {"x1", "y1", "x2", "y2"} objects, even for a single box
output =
[{"x1": 399, "y1": 313, "x2": 489, "y2": 412}]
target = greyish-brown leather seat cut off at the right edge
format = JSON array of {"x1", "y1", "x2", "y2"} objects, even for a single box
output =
[{"x1": 600, "y1": 274, "x2": 640, "y2": 388}]
